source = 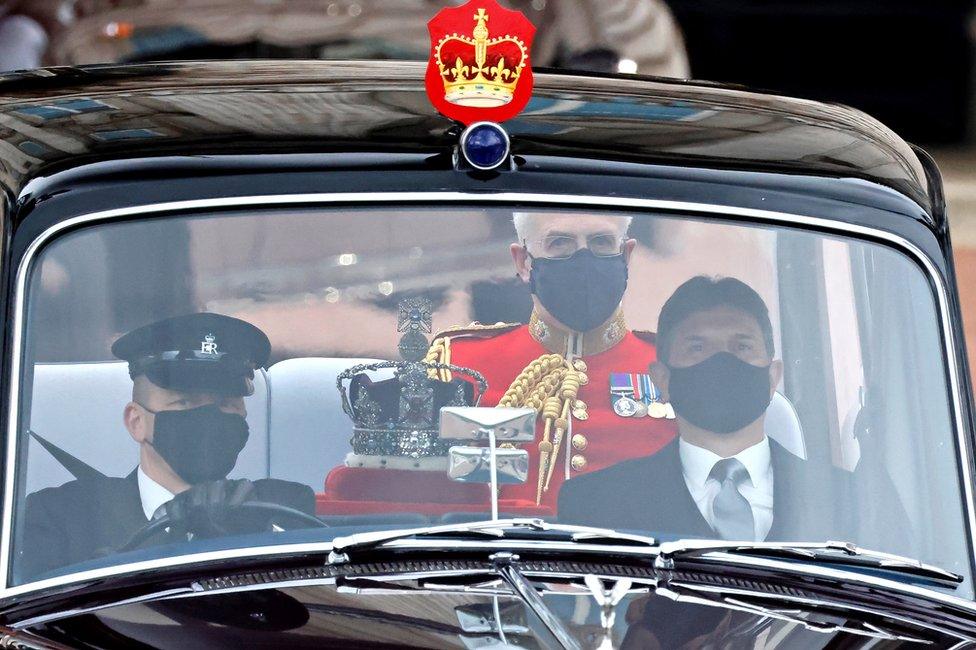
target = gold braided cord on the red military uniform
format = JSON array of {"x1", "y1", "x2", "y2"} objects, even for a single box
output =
[{"x1": 424, "y1": 336, "x2": 583, "y2": 505}]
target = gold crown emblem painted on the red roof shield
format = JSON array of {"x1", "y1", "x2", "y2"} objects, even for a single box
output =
[{"x1": 435, "y1": 9, "x2": 529, "y2": 108}]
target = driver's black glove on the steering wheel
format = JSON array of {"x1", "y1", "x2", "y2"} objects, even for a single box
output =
[{"x1": 163, "y1": 479, "x2": 255, "y2": 537}]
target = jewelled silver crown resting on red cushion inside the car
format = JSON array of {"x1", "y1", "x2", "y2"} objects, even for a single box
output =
[{"x1": 336, "y1": 298, "x2": 488, "y2": 459}]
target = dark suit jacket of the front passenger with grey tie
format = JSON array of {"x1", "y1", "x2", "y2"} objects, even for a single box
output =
[{"x1": 559, "y1": 438, "x2": 911, "y2": 552}]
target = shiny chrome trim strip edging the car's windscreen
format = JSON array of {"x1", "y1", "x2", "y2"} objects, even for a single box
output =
[{"x1": 0, "y1": 191, "x2": 976, "y2": 604}]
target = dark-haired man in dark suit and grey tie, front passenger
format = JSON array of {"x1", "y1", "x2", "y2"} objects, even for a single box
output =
[{"x1": 559, "y1": 276, "x2": 907, "y2": 549}]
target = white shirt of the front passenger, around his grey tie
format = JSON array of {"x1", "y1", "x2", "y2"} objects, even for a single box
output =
[{"x1": 678, "y1": 436, "x2": 773, "y2": 542}]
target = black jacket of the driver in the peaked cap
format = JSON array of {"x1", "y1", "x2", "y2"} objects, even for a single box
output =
[{"x1": 17, "y1": 470, "x2": 315, "y2": 580}]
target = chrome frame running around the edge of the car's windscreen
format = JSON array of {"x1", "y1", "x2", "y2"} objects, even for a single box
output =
[{"x1": 0, "y1": 191, "x2": 976, "y2": 601}]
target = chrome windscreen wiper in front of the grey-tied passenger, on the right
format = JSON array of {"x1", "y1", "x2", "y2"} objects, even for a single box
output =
[{"x1": 655, "y1": 540, "x2": 963, "y2": 589}]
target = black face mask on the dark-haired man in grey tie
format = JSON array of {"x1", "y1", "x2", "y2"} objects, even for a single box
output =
[{"x1": 668, "y1": 352, "x2": 770, "y2": 433}]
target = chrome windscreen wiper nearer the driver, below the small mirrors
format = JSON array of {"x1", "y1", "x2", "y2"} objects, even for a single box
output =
[{"x1": 329, "y1": 519, "x2": 657, "y2": 564}]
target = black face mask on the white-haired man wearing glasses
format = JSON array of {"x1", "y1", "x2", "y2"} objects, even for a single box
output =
[{"x1": 529, "y1": 248, "x2": 627, "y2": 332}]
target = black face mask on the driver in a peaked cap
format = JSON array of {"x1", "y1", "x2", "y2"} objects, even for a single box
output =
[{"x1": 147, "y1": 404, "x2": 248, "y2": 485}]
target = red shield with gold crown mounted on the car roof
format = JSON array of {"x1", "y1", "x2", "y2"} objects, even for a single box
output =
[{"x1": 424, "y1": 0, "x2": 535, "y2": 124}]
